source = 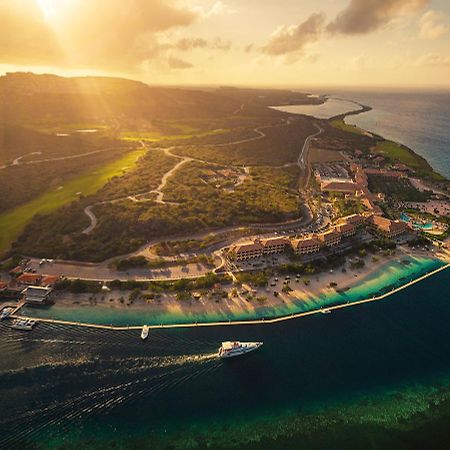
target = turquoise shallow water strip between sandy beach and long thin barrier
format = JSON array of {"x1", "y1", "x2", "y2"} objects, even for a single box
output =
[{"x1": 22, "y1": 256, "x2": 444, "y2": 325}]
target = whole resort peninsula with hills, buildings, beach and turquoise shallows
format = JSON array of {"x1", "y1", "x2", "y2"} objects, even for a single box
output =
[{"x1": 0, "y1": 74, "x2": 450, "y2": 326}]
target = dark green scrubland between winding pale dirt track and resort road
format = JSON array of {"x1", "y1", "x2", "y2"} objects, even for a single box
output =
[{"x1": 14, "y1": 161, "x2": 300, "y2": 261}]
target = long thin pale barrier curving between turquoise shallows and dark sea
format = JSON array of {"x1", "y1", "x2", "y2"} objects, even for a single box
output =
[{"x1": 9, "y1": 264, "x2": 450, "y2": 331}]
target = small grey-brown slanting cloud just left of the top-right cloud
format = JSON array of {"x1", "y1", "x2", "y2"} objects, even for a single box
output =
[{"x1": 262, "y1": 13, "x2": 325, "y2": 55}]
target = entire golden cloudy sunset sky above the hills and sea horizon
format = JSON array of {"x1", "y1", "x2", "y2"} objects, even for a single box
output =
[{"x1": 0, "y1": 0, "x2": 450, "y2": 88}]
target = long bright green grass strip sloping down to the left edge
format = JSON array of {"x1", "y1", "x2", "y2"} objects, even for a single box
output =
[{"x1": 0, "y1": 149, "x2": 146, "y2": 253}]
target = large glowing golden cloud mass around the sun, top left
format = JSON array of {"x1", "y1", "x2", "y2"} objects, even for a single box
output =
[{"x1": 0, "y1": 0, "x2": 200, "y2": 71}]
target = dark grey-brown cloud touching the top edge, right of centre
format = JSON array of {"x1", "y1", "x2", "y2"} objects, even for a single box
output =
[{"x1": 327, "y1": 0, "x2": 430, "y2": 34}]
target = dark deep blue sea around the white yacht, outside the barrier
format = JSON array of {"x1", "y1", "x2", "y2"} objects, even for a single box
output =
[{"x1": 0, "y1": 271, "x2": 450, "y2": 450}]
